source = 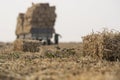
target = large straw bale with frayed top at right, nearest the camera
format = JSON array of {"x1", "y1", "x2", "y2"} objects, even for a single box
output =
[{"x1": 83, "y1": 30, "x2": 120, "y2": 61}]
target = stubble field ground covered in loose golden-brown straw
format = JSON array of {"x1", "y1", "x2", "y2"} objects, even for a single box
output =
[{"x1": 0, "y1": 43, "x2": 120, "y2": 80}]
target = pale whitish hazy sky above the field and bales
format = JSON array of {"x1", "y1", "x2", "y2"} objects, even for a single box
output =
[{"x1": 0, "y1": 0, "x2": 120, "y2": 42}]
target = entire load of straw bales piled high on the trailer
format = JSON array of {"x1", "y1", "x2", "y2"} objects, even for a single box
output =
[{"x1": 16, "y1": 3, "x2": 56, "y2": 35}]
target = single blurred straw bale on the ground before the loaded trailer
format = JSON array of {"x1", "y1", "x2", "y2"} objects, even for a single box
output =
[{"x1": 14, "y1": 39, "x2": 41, "y2": 52}]
